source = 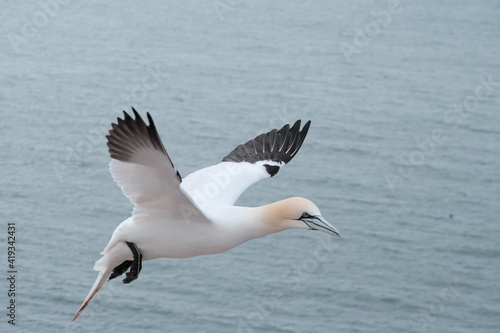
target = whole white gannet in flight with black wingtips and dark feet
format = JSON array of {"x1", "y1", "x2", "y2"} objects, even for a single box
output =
[{"x1": 73, "y1": 108, "x2": 340, "y2": 320}]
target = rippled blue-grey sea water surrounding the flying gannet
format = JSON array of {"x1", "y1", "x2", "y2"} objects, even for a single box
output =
[{"x1": 0, "y1": 0, "x2": 500, "y2": 333}]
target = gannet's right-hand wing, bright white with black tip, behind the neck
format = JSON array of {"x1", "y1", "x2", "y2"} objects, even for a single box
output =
[{"x1": 181, "y1": 120, "x2": 311, "y2": 209}]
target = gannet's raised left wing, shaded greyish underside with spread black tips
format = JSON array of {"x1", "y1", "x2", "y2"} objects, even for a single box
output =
[{"x1": 106, "y1": 108, "x2": 207, "y2": 221}]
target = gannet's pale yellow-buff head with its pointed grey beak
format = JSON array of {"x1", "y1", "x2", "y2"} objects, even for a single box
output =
[{"x1": 263, "y1": 197, "x2": 340, "y2": 237}]
